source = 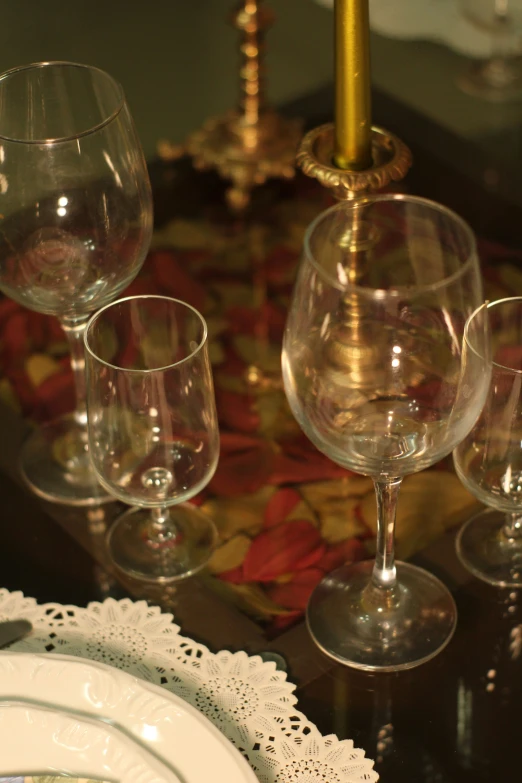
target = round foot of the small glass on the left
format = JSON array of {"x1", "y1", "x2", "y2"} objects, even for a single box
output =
[{"x1": 107, "y1": 503, "x2": 217, "y2": 582}]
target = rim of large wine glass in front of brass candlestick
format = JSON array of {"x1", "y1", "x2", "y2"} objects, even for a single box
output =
[{"x1": 303, "y1": 193, "x2": 477, "y2": 299}]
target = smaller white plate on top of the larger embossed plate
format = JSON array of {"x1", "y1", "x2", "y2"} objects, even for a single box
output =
[{"x1": 0, "y1": 702, "x2": 176, "y2": 783}]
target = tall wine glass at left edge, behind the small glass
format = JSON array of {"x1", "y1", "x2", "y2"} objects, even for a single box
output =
[{"x1": 0, "y1": 62, "x2": 152, "y2": 505}]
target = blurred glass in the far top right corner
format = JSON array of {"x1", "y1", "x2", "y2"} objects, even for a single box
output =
[{"x1": 458, "y1": 0, "x2": 522, "y2": 102}]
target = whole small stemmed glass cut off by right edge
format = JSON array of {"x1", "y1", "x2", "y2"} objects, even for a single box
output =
[{"x1": 453, "y1": 297, "x2": 522, "y2": 587}]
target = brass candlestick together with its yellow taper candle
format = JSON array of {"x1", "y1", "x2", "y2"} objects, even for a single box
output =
[{"x1": 297, "y1": 0, "x2": 411, "y2": 394}]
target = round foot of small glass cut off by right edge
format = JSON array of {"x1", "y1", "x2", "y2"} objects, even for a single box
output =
[{"x1": 457, "y1": 509, "x2": 522, "y2": 587}]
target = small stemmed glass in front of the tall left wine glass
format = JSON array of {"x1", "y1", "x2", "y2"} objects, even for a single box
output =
[{"x1": 85, "y1": 296, "x2": 219, "y2": 582}]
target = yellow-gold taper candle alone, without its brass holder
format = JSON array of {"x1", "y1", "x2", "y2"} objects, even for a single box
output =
[{"x1": 334, "y1": 0, "x2": 372, "y2": 171}]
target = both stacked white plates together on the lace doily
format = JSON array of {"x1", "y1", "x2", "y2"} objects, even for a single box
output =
[{"x1": 0, "y1": 652, "x2": 257, "y2": 783}]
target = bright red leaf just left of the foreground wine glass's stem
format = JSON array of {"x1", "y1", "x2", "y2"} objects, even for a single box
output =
[{"x1": 243, "y1": 520, "x2": 326, "y2": 582}]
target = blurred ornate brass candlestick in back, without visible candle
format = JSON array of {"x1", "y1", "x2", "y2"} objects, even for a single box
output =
[{"x1": 159, "y1": 0, "x2": 302, "y2": 211}]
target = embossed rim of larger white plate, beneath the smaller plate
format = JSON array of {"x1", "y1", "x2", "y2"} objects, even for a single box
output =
[{"x1": 0, "y1": 652, "x2": 257, "y2": 783}]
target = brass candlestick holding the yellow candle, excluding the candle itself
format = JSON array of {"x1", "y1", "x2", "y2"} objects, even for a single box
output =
[{"x1": 297, "y1": 124, "x2": 412, "y2": 402}]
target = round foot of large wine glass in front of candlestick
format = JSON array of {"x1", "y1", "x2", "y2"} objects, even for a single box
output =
[{"x1": 307, "y1": 561, "x2": 457, "y2": 672}]
